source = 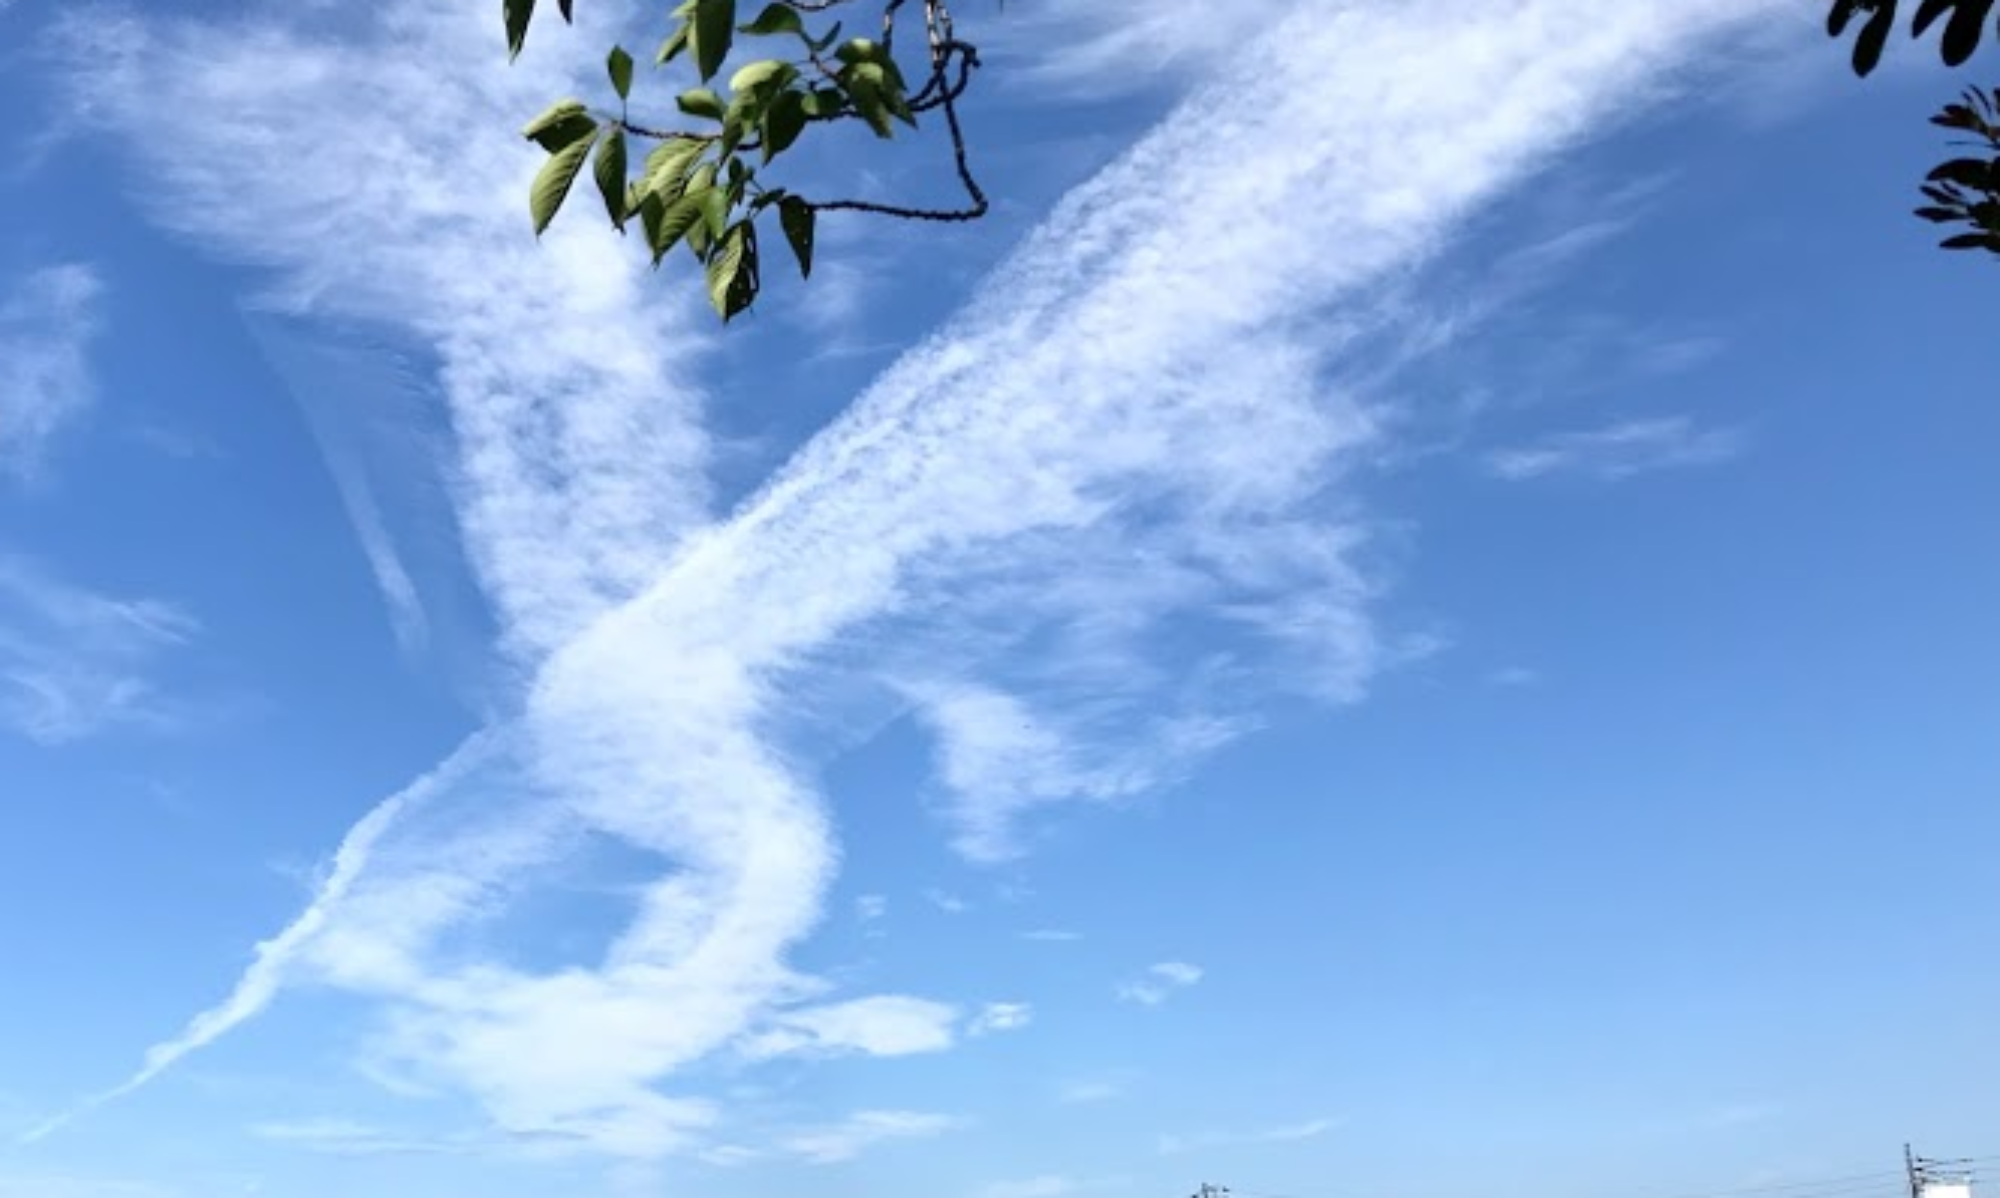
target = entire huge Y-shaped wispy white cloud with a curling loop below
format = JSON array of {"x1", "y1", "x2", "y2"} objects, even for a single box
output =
[{"x1": 47, "y1": 0, "x2": 1792, "y2": 1160}]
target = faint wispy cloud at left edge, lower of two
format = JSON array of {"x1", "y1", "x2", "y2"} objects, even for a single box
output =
[{"x1": 0, "y1": 556, "x2": 200, "y2": 744}]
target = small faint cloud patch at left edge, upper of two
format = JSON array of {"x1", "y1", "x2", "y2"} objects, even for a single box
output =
[{"x1": 0, "y1": 262, "x2": 104, "y2": 478}]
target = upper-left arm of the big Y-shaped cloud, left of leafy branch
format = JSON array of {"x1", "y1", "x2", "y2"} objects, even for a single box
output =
[{"x1": 62, "y1": 6, "x2": 708, "y2": 658}]
